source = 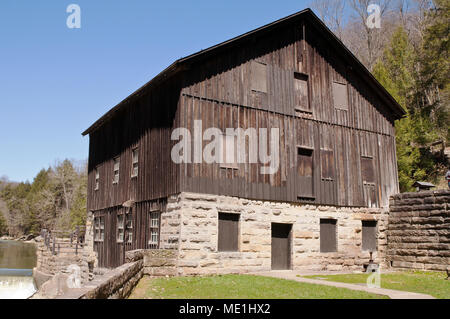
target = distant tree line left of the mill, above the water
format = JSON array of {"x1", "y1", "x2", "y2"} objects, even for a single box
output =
[{"x1": 0, "y1": 160, "x2": 87, "y2": 237}]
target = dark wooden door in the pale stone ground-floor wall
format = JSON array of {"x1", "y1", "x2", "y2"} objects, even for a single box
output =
[{"x1": 272, "y1": 223, "x2": 292, "y2": 270}]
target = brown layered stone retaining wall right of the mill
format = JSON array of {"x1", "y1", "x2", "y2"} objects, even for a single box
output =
[{"x1": 387, "y1": 190, "x2": 450, "y2": 270}]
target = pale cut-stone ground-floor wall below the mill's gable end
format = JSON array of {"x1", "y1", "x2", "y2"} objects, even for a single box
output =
[{"x1": 161, "y1": 193, "x2": 388, "y2": 275}]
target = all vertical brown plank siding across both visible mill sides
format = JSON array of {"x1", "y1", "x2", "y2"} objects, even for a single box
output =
[{"x1": 88, "y1": 15, "x2": 398, "y2": 266}]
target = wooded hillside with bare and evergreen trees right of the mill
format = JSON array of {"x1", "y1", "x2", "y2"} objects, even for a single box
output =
[{"x1": 311, "y1": 0, "x2": 450, "y2": 192}]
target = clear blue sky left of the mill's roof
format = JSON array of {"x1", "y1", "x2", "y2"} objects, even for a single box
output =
[{"x1": 0, "y1": 0, "x2": 324, "y2": 182}]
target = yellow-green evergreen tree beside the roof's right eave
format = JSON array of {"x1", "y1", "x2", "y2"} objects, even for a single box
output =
[{"x1": 374, "y1": 26, "x2": 437, "y2": 191}]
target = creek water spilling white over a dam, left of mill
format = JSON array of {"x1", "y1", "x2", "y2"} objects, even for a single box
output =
[{"x1": 0, "y1": 240, "x2": 36, "y2": 299}]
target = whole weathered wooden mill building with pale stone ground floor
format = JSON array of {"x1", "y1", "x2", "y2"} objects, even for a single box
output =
[{"x1": 83, "y1": 9, "x2": 404, "y2": 274}]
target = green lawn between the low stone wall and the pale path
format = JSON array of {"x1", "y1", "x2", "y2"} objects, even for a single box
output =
[{"x1": 130, "y1": 275, "x2": 387, "y2": 299}]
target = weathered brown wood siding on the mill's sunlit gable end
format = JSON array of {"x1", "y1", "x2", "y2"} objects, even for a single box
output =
[{"x1": 180, "y1": 18, "x2": 398, "y2": 207}]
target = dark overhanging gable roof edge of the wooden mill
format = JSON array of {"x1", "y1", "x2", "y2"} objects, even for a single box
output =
[{"x1": 82, "y1": 8, "x2": 405, "y2": 136}]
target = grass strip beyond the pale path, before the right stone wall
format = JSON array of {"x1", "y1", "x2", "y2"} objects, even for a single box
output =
[{"x1": 304, "y1": 271, "x2": 450, "y2": 299}]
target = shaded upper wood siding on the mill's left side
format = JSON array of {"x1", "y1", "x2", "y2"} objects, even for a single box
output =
[{"x1": 88, "y1": 82, "x2": 179, "y2": 211}]
